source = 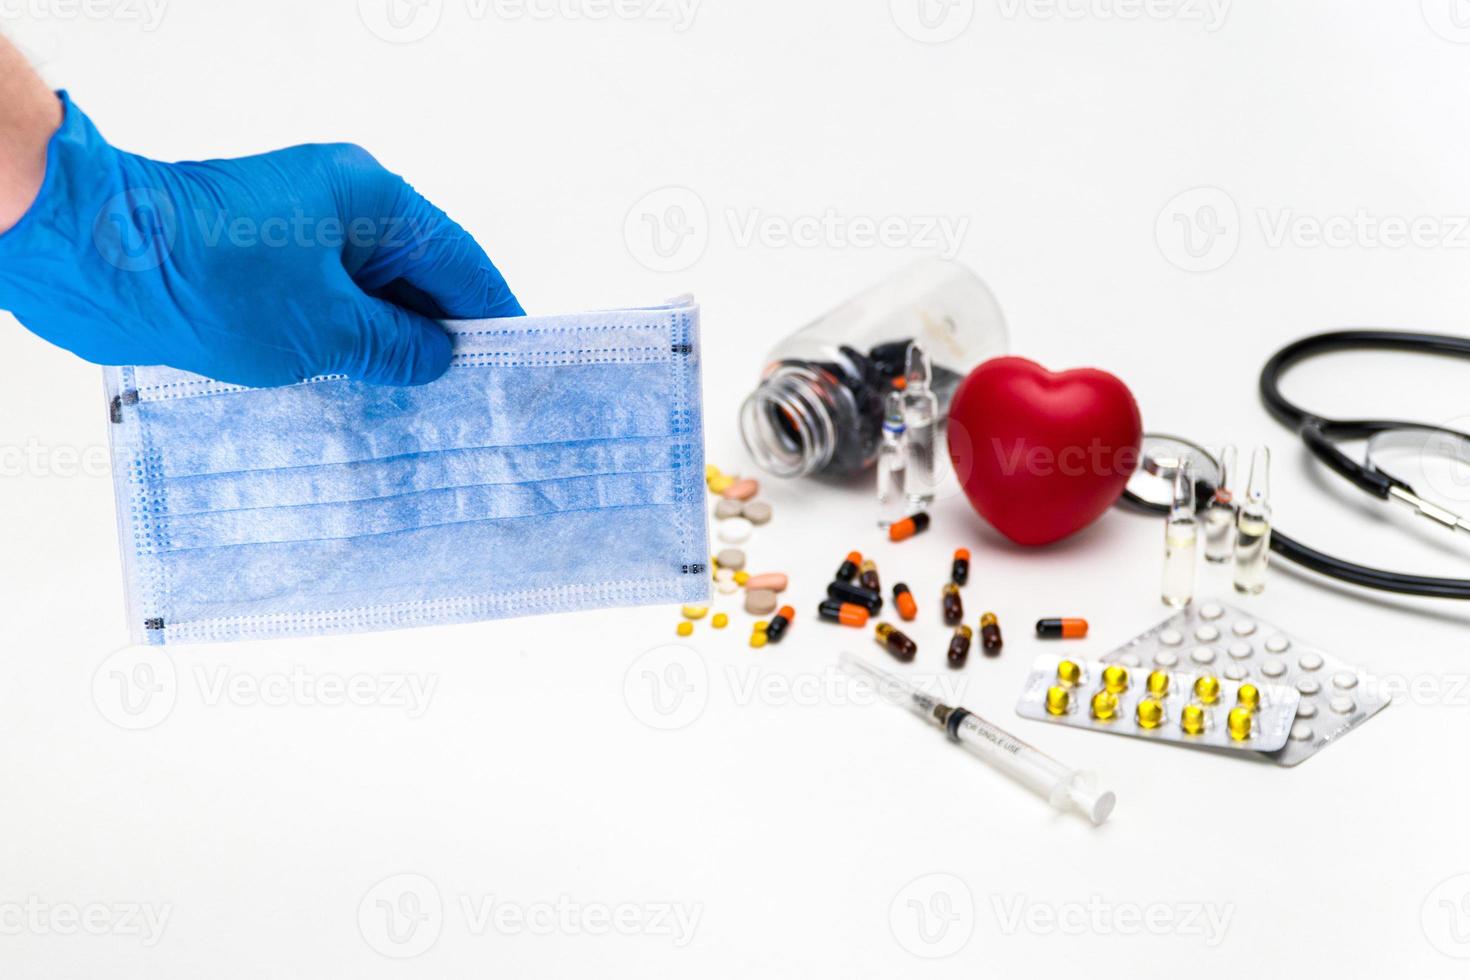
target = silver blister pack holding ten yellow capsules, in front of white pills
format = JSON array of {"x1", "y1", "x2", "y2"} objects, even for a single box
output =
[{"x1": 1016, "y1": 655, "x2": 1301, "y2": 752}]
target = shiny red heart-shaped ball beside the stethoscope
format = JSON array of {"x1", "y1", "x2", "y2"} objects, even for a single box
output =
[{"x1": 950, "y1": 357, "x2": 1144, "y2": 545}]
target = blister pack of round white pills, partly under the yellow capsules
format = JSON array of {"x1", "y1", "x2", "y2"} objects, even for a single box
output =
[{"x1": 1103, "y1": 599, "x2": 1389, "y2": 765}]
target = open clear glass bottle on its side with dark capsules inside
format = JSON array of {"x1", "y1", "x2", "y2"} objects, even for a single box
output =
[{"x1": 739, "y1": 259, "x2": 1007, "y2": 476}]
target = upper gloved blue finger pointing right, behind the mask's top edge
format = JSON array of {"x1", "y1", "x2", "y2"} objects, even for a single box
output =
[{"x1": 351, "y1": 181, "x2": 525, "y2": 319}]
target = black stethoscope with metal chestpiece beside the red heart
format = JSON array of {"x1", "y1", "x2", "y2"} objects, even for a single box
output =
[{"x1": 1123, "y1": 331, "x2": 1470, "y2": 599}]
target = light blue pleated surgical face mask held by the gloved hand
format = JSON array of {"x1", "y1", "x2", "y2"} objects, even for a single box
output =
[{"x1": 107, "y1": 304, "x2": 710, "y2": 644}]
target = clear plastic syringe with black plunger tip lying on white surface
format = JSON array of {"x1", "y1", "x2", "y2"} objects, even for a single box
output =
[{"x1": 841, "y1": 652, "x2": 1117, "y2": 824}]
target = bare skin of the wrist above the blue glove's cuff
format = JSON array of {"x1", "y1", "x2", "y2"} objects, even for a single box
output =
[{"x1": 0, "y1": 37, "x2": 62, "y2": 232}]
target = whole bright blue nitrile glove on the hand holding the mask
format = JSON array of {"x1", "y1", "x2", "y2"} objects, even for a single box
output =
[{"x1": 0, "y1": 93, "x2": 523, "y2": 386}]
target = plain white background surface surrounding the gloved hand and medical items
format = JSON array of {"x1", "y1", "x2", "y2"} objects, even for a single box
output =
[{"x1": 0, "y1": 0, "x2": 1470, "y2": 979}]
